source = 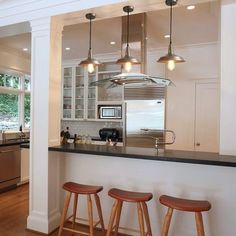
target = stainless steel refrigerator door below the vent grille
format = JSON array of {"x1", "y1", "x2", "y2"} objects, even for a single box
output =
[{"x1": 124, "y1": 99, "x2": 165, "y2": 148}]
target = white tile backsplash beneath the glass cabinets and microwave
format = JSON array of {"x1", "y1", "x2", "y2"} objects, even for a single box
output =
[{"x1": 61, "y1": 120, "x2": 123, "y2": 137}]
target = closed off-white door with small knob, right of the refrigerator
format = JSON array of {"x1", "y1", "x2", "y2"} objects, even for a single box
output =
[{"x1": 195, "y1": 83, "x2": 219, "y2": 152}]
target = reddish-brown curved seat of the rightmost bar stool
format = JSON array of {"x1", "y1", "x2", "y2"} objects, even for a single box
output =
[{"x1": 160, "y1": 195, "x2": 211, "y2": 212}]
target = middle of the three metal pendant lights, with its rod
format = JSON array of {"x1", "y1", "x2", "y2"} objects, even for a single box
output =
[{"x1": 116, "y1": 6, "x2": 140, "y2": 72}]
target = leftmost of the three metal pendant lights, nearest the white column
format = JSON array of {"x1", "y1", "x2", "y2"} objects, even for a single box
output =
[{"x1": 79, "y1": 13, "x2": 101, "y2": 73}]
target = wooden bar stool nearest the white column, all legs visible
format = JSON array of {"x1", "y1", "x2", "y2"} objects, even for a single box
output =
[{"x1": 58, "y1": 182, "x2": 105, "y2": 236}]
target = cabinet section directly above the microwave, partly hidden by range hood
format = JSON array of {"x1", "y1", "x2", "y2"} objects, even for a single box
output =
[{"x1": 98, "y1": 62, "x2": 124, "y2": 103}]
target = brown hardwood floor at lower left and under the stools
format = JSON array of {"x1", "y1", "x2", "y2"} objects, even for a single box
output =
[{"x1": 0, "y1": 184, "x2": 106, "y2": 236}]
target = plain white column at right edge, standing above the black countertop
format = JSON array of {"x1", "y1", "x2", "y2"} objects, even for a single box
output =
[{"x1": 220, "y1": 0, "x2": 236, "y2": 155}]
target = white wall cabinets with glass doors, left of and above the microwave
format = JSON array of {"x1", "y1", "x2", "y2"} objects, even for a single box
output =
[{"x1": 62, "y1": 62, "x2": 123, "y2": 120}]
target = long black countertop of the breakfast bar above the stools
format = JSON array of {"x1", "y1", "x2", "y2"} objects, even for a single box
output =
[{"x1": 49, "y1": 144, "x2": 236, "y2": 167}]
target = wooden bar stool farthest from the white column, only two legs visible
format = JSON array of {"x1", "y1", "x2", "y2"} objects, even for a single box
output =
[{"x1": 159, "y1": 195, "x2": 211, "y2": 236}]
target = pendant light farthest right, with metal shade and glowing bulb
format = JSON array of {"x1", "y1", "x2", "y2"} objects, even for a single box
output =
[{"x1": 157, "y1": 0, "x2": 185, "y2": 71}]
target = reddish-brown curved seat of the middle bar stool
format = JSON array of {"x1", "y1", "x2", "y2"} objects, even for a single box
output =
[{"x1": 108, "y1": 188, "x2": 152, "y2": 202}]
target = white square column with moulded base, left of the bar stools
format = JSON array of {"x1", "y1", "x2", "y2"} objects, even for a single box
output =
[{"x1": 27, "y1": 17, "x2": 62, "y2": 234}]
